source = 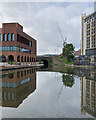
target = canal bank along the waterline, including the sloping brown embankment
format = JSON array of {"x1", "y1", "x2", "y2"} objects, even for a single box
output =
[{"x1": 0, "y1": 56, "x2": 95, "y2": 71}]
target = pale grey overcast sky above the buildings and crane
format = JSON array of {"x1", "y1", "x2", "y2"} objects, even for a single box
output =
[{"x1": 0, "y1": 2, "x2": 94, "y2": 54}]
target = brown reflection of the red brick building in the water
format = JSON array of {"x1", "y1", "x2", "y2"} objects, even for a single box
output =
[{"x1": 0, "y1": 69, "x2": 36, "y2": 108}]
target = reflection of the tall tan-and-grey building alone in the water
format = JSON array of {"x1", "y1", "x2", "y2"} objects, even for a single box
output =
[{"x1": 81, "y1": 77, "x2": 96, "y2": 117}]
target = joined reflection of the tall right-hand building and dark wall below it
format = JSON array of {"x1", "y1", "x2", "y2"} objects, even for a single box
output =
[{"x1": 74, "y1": 68, "x2": 96, "y2": 118}]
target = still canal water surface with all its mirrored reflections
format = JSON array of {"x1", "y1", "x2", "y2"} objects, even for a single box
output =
[{"x1": 0, "y1": 68, "x2": 96, "y2": 118}]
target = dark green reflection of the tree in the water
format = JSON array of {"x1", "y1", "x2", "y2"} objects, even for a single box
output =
[{"x1": 62, "y1": 75, "x2": 75, "y2": 87}]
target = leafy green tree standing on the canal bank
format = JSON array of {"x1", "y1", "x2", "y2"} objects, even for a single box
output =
[{"x1": 62, "y1": 44, "x2": 74, "y2": 61}]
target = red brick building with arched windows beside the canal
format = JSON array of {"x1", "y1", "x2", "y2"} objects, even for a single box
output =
[{"x1": 0, "y1": 23, "x2": 37, "y2": 64}]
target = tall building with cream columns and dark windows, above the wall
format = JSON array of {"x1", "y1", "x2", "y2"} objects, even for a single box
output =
[{"x1": 81, "y1": 2, "x2": 96, "y2": 56}]
